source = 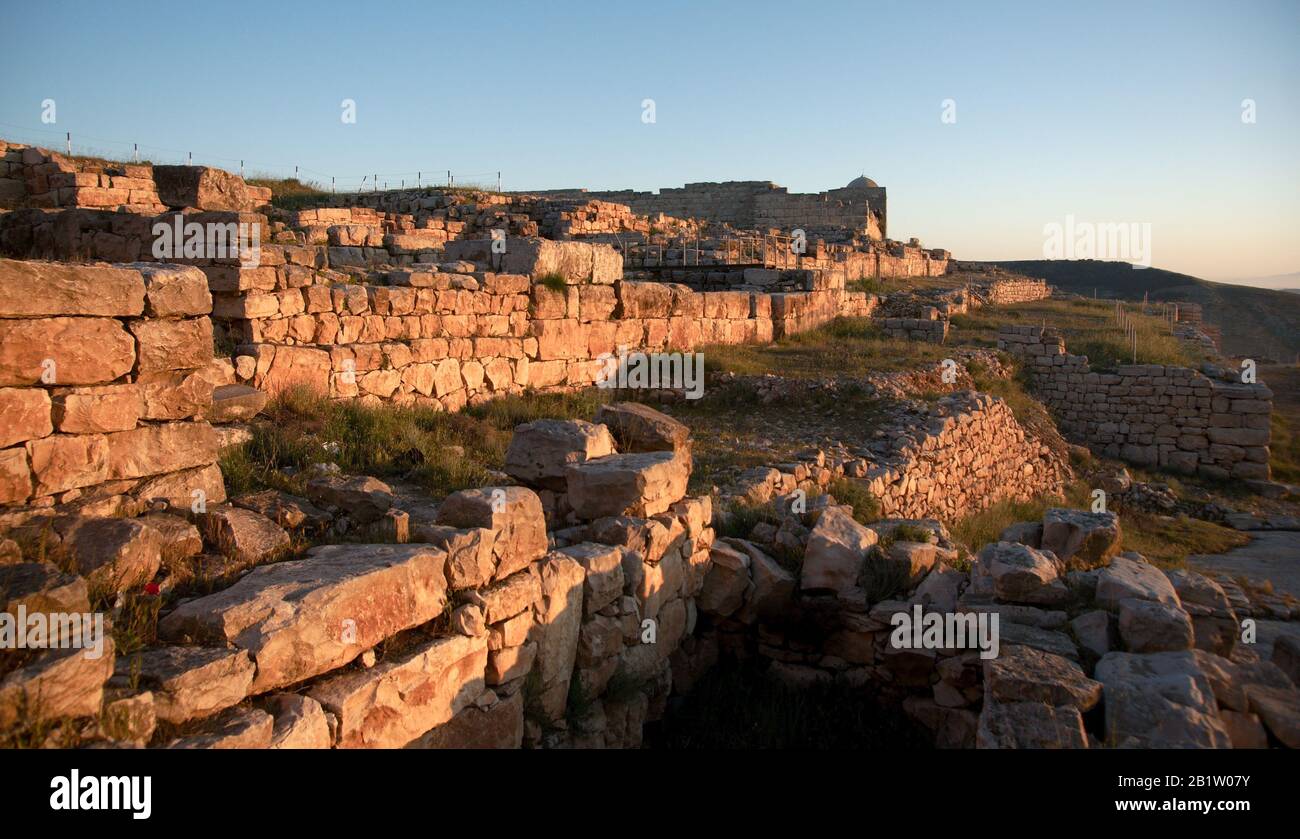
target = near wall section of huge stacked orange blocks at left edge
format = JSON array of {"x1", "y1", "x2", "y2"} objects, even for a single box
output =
[{"x1": 0, "y1": 259, "x2": 225, "y2": 510}]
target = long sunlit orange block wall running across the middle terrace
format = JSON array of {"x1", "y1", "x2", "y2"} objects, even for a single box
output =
[{"x1": 204, "y1": 239, "x2": 871, "y2": 410}]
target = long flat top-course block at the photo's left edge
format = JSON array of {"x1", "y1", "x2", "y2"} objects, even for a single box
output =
[{"x1": 0, "y1": 259, "x2": 144, "y2": 317}]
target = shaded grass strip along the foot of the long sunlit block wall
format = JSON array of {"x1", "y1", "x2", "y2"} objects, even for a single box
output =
[{"x1": 221, "y1": 388, "x2": 608, "y2": 497}]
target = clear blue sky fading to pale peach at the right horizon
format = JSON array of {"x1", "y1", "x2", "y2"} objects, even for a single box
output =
[{"x1": 0, "y1": 0, "x2": 1300, "y2": 285}]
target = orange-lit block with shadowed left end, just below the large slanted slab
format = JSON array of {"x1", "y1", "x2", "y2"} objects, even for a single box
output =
[{"x1": 114, "y1": 646, "x2": 254, "y2": 723}]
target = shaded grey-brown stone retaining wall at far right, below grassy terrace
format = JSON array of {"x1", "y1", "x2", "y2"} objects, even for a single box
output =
[{"x1": 997, "y1": 326, "x2": 1273, "y2": 480}]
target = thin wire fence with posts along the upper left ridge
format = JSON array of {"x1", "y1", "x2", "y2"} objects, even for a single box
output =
[{"x1": 0, "y1": 122, "x2": 502, "y2": 193}]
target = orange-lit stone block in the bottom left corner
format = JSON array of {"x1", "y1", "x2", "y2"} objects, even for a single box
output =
[{"x1": 0, "y1": 632, "x2": 113, "y2": 730}]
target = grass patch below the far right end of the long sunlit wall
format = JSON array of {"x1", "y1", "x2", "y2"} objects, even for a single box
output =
[{"x1": 703, "y1": 317, "x2": 950, "y2": 379}]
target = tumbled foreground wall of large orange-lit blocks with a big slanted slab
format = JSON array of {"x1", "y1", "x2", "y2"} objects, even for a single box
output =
[{"x1": 0, "y1": 405, "x2": 714, "y2": 748}]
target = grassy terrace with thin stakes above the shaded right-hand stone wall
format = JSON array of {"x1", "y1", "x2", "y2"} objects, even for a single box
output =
[{"x1": 949, "y1": 299, "x2": 1203, "y2": 371}]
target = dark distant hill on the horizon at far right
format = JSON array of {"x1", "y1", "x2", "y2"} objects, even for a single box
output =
[{"x1": 989, "y1": 259, "x2": 1300, "y2": 362}]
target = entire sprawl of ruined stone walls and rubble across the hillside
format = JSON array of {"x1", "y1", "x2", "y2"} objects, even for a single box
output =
[{"x1": 0, "y1": 144, "x2": 1300, "y2": 748}]
